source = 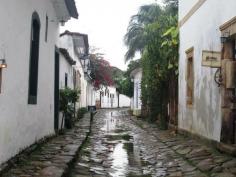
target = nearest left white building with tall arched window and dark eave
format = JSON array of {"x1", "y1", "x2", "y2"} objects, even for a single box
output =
[{"x1": 0, "y1": 0, "x2": 78, "y2": 164}]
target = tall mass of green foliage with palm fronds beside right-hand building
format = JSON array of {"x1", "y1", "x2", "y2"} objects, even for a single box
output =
[{"x1": 125, "y1": 0, "x2": 179, "y2": 129}]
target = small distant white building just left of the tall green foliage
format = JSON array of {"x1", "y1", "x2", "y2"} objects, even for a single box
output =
[{"x1": 130, "y1": 68, "x2": 142, "y2": 116}]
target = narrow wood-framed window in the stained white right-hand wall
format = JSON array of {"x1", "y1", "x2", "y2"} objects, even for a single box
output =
[{"x1": 186, "y1": 48, "x2": 194, "y2": 105}]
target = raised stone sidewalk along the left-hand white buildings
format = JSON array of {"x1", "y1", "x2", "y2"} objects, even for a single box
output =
[{"x1": 0, "y1": 113, "x2": 92, "y2": 177}]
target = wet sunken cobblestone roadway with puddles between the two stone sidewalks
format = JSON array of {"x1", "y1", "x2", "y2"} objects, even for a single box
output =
[{"x1": 72, "y1": 112, "x2": 155, "y2": 177}]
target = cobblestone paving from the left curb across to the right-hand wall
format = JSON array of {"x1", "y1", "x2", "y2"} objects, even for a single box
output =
[{"x1": 71, "y1": 110, "x2": 236, "y2": 177}]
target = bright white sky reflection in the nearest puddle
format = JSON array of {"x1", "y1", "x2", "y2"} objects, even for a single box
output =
[{"x1": 111, "y1": 143, "x2": 128, "y2": 177}]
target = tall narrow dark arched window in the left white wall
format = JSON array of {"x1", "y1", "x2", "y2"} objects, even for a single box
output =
[{"x1": 28, "y1": 12, "x2": 40, "y2": 104}]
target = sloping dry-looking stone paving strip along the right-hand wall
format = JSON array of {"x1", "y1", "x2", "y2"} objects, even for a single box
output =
[{"x1": 131, "y1": 111, "x2": 236, "y2": 177}]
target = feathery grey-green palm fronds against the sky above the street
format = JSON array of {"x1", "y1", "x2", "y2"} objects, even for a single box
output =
[{"x1": 124, "y1": 4, "x2": 163, "y2": 62}]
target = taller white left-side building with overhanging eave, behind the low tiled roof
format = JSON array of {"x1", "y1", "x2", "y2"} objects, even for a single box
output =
[{"x1": 60, "y1": 31, "x2": 96, "y2": 107}]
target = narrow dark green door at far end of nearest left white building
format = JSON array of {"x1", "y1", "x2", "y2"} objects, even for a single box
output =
[{"x1": 54, "y1": 48, "x2": 60, "y2": 131}]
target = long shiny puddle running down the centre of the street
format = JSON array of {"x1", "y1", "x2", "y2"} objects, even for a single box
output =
[{"x1": 101, "y1": 112, "x2": 150, "y2": 177}]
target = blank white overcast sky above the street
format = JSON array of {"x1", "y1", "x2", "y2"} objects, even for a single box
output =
[{"x1": 61, "y1": 0, "x2": 162, "y2": 70}]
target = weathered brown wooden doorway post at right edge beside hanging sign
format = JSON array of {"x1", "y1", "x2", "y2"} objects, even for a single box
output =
[{"x1": 220, "y1": 36, "x2": 236, "y2": 144}]
